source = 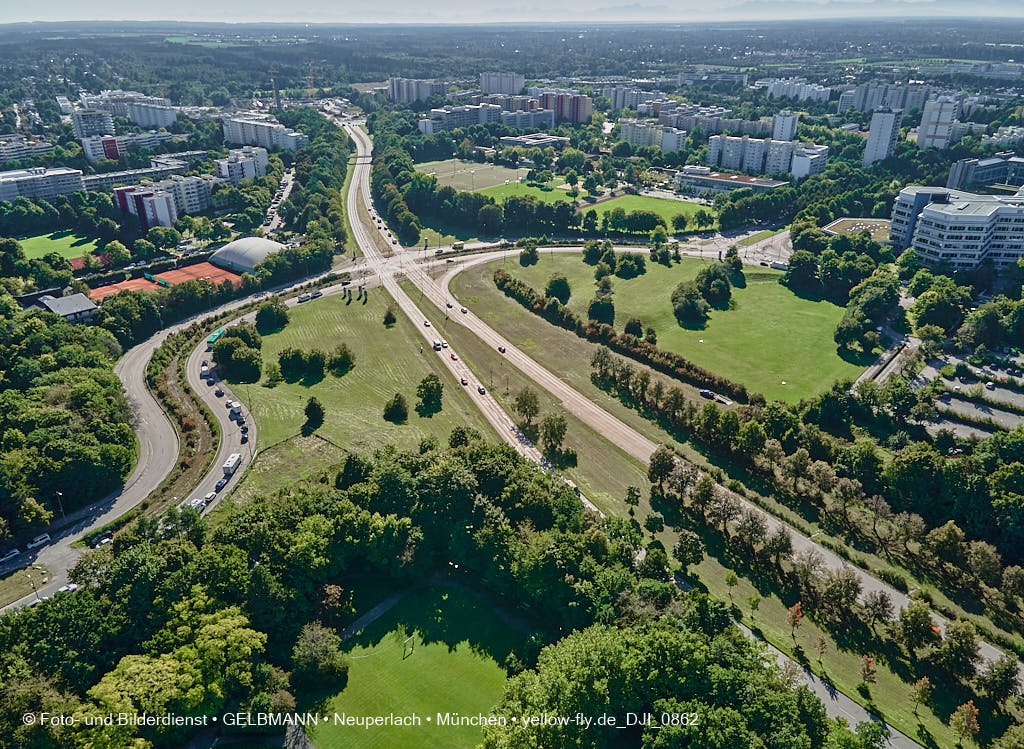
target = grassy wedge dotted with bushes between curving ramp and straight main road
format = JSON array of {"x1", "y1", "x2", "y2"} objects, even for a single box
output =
[{"x1": 233, "y1": 289, "x2": 490, "y2": 452}]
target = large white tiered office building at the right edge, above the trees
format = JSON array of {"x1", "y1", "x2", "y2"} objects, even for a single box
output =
[{"x1": 889, "y1": 185, "x2": 1024, "y2": 269}]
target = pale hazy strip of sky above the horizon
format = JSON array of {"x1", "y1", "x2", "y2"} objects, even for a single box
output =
[{"x1": 6, "y1": 0, "x2": 1024, "y2": 24}]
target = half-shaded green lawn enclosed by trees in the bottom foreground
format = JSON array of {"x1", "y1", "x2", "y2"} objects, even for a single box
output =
[{"x1": 310, "y1": 587, "x2": 521, "y2": 749}]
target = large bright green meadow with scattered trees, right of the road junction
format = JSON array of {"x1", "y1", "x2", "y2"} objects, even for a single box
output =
[{"x1": 466, "y1": 253, "x2": 866, "y2": 402}]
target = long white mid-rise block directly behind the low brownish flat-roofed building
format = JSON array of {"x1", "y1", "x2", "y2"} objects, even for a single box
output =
[{"x1": 707, "y1": 135, "x2": 828, "y2": 179}]
